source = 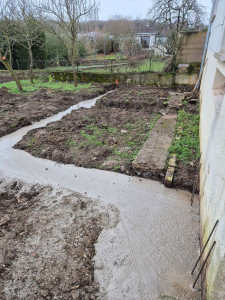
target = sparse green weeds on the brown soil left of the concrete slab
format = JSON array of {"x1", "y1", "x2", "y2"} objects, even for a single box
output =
[{"x1": 77, "y1": 115, "x2": 159, "y2": 165}]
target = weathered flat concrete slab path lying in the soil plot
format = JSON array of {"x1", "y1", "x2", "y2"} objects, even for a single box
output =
[{"x1": 133, "y1": 115, "x2": 176, "y2": 178}]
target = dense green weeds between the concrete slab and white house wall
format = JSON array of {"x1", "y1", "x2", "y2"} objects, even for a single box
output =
[{"x1": 169, "y1": 110, "x2": 200, "y2": 163}]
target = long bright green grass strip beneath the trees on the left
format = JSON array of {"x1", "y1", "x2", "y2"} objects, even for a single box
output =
[{"x1": 0, "y1": 79, "x2": 92, "y2": 94}]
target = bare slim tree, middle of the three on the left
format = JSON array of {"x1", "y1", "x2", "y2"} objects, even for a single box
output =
[{"x1": 9, "y1": 0, "x2": 44, "y2": 83}]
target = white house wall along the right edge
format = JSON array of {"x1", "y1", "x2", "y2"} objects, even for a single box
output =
[{"x1": 200, "y1": 0, "x2": 225, "y2": 300}]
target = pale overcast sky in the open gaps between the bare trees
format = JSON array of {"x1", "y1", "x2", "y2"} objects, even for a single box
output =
[{"x1": 99, "y1": 0, "x2": 212, "y2": 20}]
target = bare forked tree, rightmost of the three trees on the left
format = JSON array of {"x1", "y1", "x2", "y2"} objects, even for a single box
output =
[{"x1": 39, "y1": 0, "x2": 99, "y2": 86}]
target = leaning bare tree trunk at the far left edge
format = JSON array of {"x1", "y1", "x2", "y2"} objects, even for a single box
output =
[{"x1": 0, "y1": 1, "x2": 23, "y2": 92}]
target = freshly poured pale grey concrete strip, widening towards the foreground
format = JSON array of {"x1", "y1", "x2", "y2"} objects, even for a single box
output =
[{"x1": 0, "y1": 92, "x2": 199, "y2": 300}]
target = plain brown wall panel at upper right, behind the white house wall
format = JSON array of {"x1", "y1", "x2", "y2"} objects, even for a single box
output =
[{"x1": 177, "y1": 31, "x2": 207, "y2": 64}]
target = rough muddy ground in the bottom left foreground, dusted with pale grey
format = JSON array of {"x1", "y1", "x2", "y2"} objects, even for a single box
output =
[{"x1": 0, "y1": 178, "x2": 118, "y2": 300}]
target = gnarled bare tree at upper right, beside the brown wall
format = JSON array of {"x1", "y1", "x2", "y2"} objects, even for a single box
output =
[{"x1": 148, "y1": 0, "x2": 205, "y2": 71}]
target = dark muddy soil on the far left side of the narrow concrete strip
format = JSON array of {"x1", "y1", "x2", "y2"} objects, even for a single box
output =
[{"x1": 0, "y1": 85, "x2": 113, "y2": 137}]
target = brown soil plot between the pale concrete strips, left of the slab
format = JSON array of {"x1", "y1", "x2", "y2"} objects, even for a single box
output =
[{"x1": 15, "y1": 86, "x2": 199, "y2": 190}]
